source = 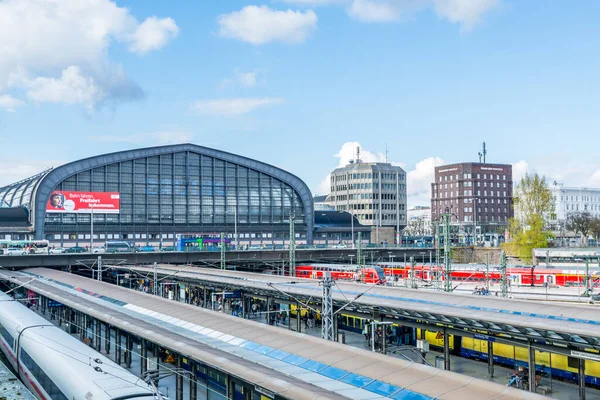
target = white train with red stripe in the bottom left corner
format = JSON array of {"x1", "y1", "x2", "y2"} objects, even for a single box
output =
[{"x1": 0, "y1": 292, "x2": 155, "y2": 400}]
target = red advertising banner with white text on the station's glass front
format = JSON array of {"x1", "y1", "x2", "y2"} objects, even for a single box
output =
[{"x1": 46, "y1": 191, "x2": 121, "y2": 214}]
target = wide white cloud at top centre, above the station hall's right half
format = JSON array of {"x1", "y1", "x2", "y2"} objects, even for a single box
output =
[{"x1": 217, "y1": 6, "x2": 317, "y2": 46}]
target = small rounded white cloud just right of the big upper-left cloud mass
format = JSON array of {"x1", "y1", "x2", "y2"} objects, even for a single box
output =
[{"x1": 129, "y1": 17, "x2": 179, "y2": 54}]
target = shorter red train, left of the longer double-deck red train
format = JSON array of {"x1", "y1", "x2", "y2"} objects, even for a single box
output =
[{"x1": 296, "y1": 264, "x2": 385, "y2": 285}]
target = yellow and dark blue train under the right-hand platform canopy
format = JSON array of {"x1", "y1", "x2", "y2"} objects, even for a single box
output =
[{"x1": 340, "y1": 315, "x2": 600, "y2": 387}]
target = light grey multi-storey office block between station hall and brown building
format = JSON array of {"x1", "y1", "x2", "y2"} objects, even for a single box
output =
[{"x1": 326, "y1": 146, "x2": 406, "y2": 242}]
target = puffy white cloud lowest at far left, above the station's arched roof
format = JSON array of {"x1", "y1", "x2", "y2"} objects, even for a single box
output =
[{"x1": 27, "y1": 66, "x2": 105, "y2": 107}]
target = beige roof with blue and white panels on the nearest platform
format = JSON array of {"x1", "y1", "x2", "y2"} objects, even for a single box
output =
[{"x1": 0, "y1": 268, "x2": 543, "y2": 400}]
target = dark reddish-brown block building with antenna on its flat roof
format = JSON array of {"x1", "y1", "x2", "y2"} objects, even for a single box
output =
[{"x1": 431, "y1": 162, "x2": 514, "y2": 242}]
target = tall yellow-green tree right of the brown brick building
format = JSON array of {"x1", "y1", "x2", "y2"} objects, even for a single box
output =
[{"x1": 505, "y1": 174, "x2": 554, "y2": 263}]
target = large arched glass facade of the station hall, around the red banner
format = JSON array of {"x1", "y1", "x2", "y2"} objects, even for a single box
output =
[{"x1": 44, "y1": 151, "x2": 306, "y2": 241}]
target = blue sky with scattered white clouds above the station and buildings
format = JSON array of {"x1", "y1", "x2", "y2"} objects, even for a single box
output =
[{"x1": 0, "y1": 0, "x2": 600, "y2": 206}]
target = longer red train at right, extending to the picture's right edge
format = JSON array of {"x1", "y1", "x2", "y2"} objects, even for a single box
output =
[{"x1": 376, "y1": 262, "x2": 600, "y2": 288}]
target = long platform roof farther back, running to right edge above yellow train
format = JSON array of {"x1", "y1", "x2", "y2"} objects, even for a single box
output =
[{"x1": 123, "y1": 265, "x2": 600, "y2": 350}]
